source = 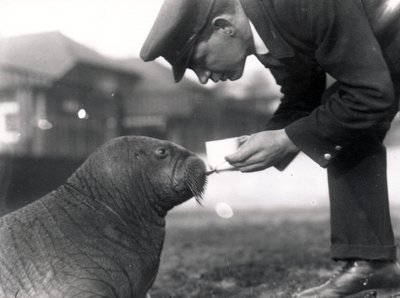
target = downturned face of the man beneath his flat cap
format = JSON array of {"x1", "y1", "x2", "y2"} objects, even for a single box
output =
[{"x1": 189, "y1": 30, "x2": 250, "y2": 84}]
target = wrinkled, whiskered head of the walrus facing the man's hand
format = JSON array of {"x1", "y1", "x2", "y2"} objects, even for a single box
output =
[{"x1": 70, "y1": 136, "x2": 206, "y2": 215}]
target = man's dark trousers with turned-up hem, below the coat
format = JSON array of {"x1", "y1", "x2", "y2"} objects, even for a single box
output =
[{"x1": 328, "y1": 75, "x2": 400, "y2": 260}]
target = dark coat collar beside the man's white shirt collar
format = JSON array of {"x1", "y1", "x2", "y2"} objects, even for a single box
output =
[{"x1": 240, "y1": 0, "x2": 295, "y2": 59}]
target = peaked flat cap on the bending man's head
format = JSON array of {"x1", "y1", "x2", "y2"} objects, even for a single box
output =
[{"x1": 140, "y1": 0, "x2": 216, "y2": 82}]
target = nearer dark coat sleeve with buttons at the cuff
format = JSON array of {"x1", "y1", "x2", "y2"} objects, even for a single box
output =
[{"x1": 282, "y1": 0, "x2": 394, "y2": 167}]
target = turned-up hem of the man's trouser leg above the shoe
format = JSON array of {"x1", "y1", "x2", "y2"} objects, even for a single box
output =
[{"x1": 331, "y1": 244, "x2": 397, "y2": 261}]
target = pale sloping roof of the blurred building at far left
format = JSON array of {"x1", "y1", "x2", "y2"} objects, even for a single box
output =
[{"x1": 0, "y1": 31, "x2": 133, "y2": 79}]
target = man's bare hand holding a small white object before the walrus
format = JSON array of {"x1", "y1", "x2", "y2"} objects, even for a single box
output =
[{"x1": 225, "y1": 129, "x2": 299, "y2": 172}]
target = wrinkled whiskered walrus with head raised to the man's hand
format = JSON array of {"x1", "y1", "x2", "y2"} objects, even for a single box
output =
[{"x1": 0, "y1": 136, "x2": 206, "y2": 298}]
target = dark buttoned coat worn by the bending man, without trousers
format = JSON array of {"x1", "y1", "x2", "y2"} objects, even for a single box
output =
[{"x1": 241, "y1": 0, "x2": 400, "y2": 167}]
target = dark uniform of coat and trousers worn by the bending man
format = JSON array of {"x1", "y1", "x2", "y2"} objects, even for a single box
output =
[{"x1": 241, "y1": 0, "x2": 400, "y2": 260}]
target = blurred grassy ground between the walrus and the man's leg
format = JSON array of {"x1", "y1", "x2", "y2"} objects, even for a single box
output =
[{"x1": 151, "y1": 210, "x2": 400, "y2": 298}]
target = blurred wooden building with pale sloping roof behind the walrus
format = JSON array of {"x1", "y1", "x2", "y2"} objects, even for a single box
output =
[{"x1": 0, "y1": 32, "x2": 138, "y2": 159}]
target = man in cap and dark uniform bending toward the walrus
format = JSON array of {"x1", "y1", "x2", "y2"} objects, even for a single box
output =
[{"x1": 141, "y1": 0, "x2": 400, "y2": 298}]
